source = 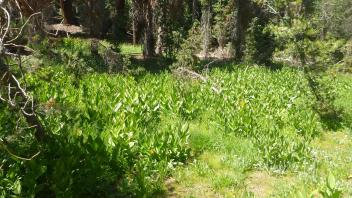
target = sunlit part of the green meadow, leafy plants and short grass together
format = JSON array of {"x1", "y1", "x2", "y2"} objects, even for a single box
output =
[{"x1": 28, "y1": 66, "x2": 350, "y2": 197}]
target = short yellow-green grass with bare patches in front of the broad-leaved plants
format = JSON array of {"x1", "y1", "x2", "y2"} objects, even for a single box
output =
[{"x1": 166, "y1": 75, "x2": 352, "y2": 197}]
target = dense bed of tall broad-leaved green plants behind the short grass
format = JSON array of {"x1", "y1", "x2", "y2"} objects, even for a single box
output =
[{"x1": 1, "y1": 50, "x2": 328, "y2": 196}]
